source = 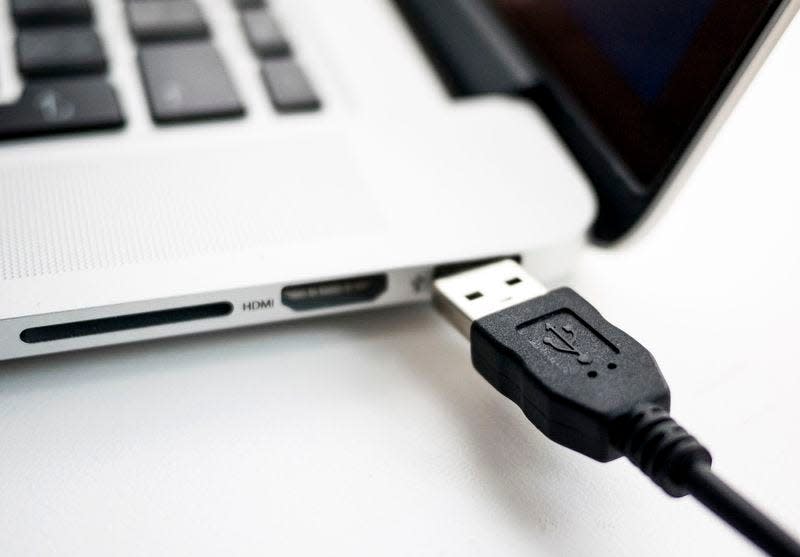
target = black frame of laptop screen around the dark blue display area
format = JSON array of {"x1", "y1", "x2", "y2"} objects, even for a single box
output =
[{"x1": 491, "y1": 0, "x2": 788, "y2": 241}]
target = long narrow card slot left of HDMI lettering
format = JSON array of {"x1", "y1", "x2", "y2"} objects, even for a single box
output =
[{"x1": 19, "y1": 302, "x2": 233, "y2": 344}]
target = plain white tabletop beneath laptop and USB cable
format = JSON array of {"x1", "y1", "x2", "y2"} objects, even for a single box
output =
[{"x1": 0, "y1": 9, "x2": 800, "y2": 556}]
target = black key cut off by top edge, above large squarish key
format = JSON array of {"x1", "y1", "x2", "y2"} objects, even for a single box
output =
[{"x1": 127, "y1": 0, "x2": 208, "y2": 42}]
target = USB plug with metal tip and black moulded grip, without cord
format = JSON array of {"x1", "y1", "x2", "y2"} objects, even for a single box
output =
[{"x1": 434, "y1": 260, "x2": 670, "y2": 462}]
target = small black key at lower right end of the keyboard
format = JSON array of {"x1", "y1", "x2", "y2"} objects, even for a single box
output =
[{"x1": 261, "y1": 58, "x2": 320, "y2": 112}]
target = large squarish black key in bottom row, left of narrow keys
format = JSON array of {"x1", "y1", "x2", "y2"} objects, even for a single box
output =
[{"x1": 139, "y1": 42, "x2": 244, "y2": 123}]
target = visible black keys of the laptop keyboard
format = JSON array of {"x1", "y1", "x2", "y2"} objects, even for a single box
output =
[{"x1": 0, "y1": 0, "x2": 321, "y2": 139}]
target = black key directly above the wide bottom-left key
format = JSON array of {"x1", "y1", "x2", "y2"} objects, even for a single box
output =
[{"x1": 17, "y1": 27, "x2": 106, "y2": 77}]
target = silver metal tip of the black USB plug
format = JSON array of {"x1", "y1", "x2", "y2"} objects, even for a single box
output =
[{"x1": 433, "y1": 259, "x2": 547, "y2": 338}]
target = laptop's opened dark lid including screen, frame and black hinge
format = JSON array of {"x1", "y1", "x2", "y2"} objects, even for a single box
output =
[{"x1": 397, "y1": 0, "x2": 800, "y2": 242}]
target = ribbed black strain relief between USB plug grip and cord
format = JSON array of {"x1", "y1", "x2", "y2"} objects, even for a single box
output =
[{"x1": 615, "y1": 404, "x2": 711, "y2": 497}]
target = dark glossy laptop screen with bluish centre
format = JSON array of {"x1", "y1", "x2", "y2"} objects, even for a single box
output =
[{"x1": 492, "y1": 0, "x2": 781, "y2": 188}]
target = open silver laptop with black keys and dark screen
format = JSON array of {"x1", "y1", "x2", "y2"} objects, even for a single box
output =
[{"x1": 0, "y1": 0, "x2": 800, "y2": 360}]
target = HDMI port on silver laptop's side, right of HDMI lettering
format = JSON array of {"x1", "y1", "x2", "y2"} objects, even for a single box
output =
[{"x1": 281, "y1": 275, "x2": 387, "y2": 311}]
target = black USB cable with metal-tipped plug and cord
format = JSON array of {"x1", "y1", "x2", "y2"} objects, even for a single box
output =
[{"x1": 433, "y1": 260, "x2": 800, "y2": 557}]
